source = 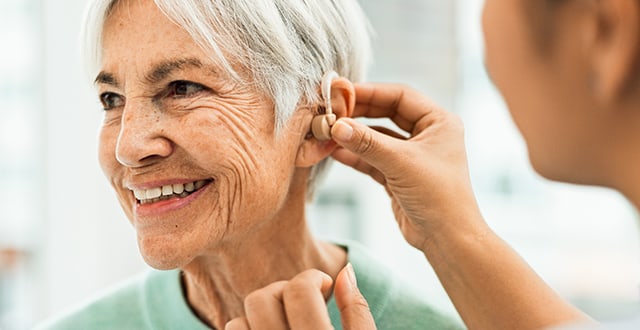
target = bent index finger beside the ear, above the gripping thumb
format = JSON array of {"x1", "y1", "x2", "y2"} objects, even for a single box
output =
[{"x1": 353, "y1": 83, "x2": 438, "y2": 132}]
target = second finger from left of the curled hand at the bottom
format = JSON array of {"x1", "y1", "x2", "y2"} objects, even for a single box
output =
[{"x1": 244, "y1": 281, "x2": 288, "y2": 330}]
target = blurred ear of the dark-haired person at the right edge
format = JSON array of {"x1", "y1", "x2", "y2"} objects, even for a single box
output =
[{"x1": 593, "y1": 0, "x2": 640, "y2": 103}]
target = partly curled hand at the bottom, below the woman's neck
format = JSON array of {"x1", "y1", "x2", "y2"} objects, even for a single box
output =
[{"x1": 225, "y1": 264, "x2": 376, "y2": 330}]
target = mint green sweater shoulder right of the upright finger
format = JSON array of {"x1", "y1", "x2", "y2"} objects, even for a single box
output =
[{"x1": 343, "y1": 242, "x2": 464, "y2": 329}]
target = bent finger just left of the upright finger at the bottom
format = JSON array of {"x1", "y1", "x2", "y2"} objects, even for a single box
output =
[{"x1": 283, "y1": 269, "x2": 333, "y2": 330}]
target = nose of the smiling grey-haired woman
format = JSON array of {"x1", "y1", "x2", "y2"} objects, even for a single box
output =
[{"x1": 116, "y1": 105, "x2": 173, "y2": 168}]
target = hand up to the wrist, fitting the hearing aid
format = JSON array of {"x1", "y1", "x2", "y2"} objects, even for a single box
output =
[{"x1": 332, "y1": 84, "x2": 484, "y2": 251}]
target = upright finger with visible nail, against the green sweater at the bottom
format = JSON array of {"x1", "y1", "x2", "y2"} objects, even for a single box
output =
[{"x1": 334, "y1": 264, "x2": 376, "y2": 330}]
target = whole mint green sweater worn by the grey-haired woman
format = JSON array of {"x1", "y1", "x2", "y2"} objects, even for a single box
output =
[{"x1": 37, "y1": 242, "x2": 462, "y2": 330}]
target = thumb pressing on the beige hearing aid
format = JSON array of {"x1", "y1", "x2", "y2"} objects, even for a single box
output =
[{"x1": 331, "y1": 118, "x2": 397, "y2": 169}]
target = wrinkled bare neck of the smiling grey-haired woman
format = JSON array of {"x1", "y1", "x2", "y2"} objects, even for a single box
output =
[{"x1": 178, "y1": 218, "x2": 346, "y2": 329}]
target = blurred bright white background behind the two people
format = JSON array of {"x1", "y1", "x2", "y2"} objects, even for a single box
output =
[{"x1": 0, "y1": 0, "x2": 640, "y2": 330}]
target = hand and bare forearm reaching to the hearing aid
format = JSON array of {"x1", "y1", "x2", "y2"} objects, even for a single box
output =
[{"x1": 331, "y1": 84, "x2": 589, "y2": 329}]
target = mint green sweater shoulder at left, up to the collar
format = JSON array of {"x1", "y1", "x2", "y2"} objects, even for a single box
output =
[{"x1": 36, "y1": 272, "x2": 160, "y2": 330}]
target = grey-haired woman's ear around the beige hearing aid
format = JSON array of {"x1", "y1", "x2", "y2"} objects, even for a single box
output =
[{"x1": 296, "y1": 77, "x2": 356, "y2": 167}]
